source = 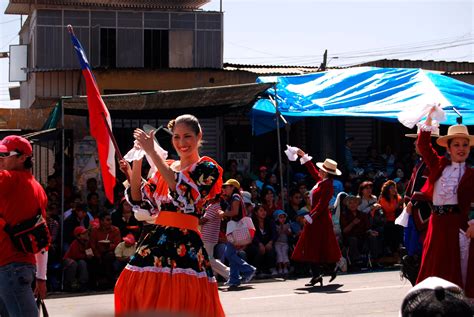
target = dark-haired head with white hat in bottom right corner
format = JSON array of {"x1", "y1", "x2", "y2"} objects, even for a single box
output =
[{"x1": 399, "y1": 276, "x2": 474, "y2": 317}]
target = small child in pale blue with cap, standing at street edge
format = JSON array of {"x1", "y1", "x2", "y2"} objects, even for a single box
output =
[{"x1": 273, "y1": 210, "x2": 291, "y2": 275}]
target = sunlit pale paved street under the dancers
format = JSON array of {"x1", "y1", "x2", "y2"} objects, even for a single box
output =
[{"x1": 46, "y1": 271, "x2": 410, "y2": 317}]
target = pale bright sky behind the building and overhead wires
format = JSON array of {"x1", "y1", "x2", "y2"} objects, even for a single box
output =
[{"x1": 0, "y1": 0, "x2": 474, "y2": 108}]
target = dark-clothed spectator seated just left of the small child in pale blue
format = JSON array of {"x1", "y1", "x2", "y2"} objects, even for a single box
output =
[{"x1": 245, "y1": 204, "x2": 278, "y2": 276}]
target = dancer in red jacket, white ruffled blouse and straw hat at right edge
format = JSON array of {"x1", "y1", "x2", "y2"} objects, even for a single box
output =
[{"x1": 417, "y1": 109, "x2": 474, "y2": 298}]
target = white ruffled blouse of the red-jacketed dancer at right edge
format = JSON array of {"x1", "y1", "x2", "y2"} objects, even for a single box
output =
[{"x1": 433, "y1": 162, "x2": 466, "y2": 206}]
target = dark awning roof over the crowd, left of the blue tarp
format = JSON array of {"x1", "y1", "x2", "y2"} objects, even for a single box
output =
[{"x1": 63, "y1": 83, "x2": 272, "y2": 118}]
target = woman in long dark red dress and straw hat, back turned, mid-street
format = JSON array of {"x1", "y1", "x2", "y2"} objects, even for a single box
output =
[{"x1": 291, "y1": 149, "x2": 341, "y2": 286}]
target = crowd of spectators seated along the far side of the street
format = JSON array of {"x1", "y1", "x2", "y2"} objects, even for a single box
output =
[{"x1": 46, "y1": 138, "x2": 470, "y2": 290}]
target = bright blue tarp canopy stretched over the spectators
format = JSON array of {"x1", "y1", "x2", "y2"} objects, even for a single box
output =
[{"x1": 251, "y1": 67, "x2": 474, "y2": 135}]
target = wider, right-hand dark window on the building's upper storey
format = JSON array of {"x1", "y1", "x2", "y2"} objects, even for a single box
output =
[{"x1": 144, "y1": 30, "x2": 169, "y2": 68}]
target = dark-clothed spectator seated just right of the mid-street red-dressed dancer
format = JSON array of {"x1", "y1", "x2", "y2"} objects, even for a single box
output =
[{"x1": 341, "y1": 195, "x2": 369, "y2": 265}]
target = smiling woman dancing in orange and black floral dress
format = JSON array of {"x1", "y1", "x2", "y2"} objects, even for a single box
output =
[{"x1": 115, "y1": 115, "x2": 224, "y2": 316}]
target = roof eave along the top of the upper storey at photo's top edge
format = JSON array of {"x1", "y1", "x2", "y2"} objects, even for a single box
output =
[{"x1": 5, "y1": 0, "x2": 210, "y2": 15}]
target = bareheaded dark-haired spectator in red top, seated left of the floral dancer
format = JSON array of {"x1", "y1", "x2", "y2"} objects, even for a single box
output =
[{"x1": 90, "y1": 211, "x2": 121, "y2": 288}]
